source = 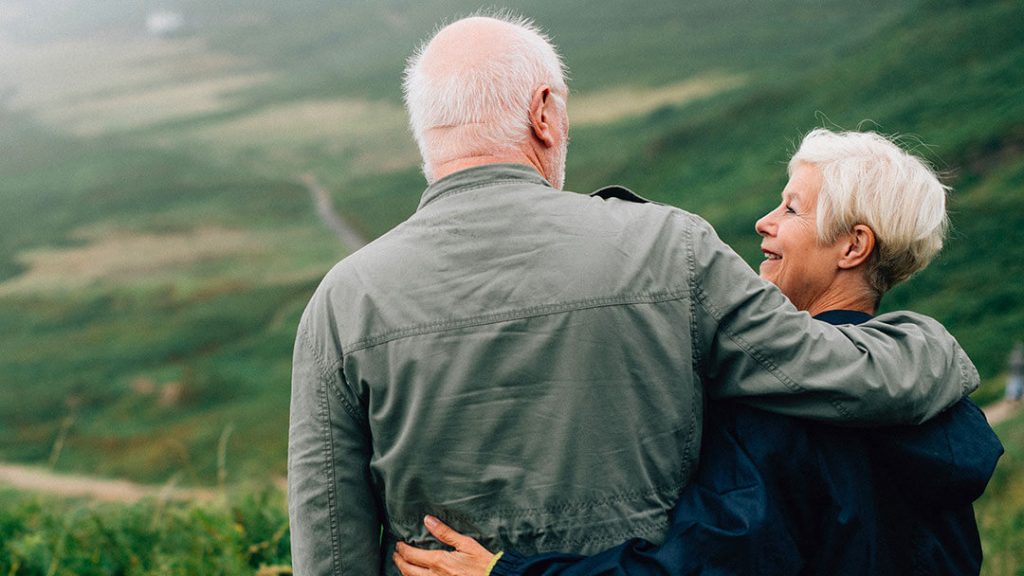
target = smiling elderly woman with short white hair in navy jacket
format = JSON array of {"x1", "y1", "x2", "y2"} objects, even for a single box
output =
[{"x1": 394, "y1": 129, "x2": 1002, "y2": 576}]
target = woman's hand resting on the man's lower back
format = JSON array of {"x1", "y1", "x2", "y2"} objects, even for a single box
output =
[{"x1": 392, "y1": 516, "x2": 495, "y2": 576}]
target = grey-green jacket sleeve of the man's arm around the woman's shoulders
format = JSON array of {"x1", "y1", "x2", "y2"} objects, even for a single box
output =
[{"x1": 686, "y1": 214, "x2": 979, "y2": 425}]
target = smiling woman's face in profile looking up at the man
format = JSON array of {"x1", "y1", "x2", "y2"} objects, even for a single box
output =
[{"x1": 755, "y1": 164, "x2": 840, "y2": 314}]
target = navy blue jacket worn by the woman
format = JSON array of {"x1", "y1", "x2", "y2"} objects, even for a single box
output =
[{"x1": 492, "y1": 311, "x2": 1002, "y2": 576}]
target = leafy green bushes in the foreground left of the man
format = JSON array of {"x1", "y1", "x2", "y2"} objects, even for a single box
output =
[{"x1": 0, "y1": 490, "x2": 292, "y2": 576}]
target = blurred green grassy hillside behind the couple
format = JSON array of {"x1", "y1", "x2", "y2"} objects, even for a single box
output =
[{"x1": 0, "y1": 0, "x2": 1024, "y2": 574}]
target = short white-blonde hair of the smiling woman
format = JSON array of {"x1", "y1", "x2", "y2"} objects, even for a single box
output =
[{"x1": 788, "y1": 128, "x2": 949, "y2": 298}]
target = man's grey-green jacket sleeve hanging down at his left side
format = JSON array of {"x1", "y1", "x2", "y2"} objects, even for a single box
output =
[{"x1": 288, "y1": 323, "x2": 381, "y2": 575}]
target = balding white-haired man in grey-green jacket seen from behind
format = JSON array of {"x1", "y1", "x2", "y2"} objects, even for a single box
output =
[{"x1": 289, "y1": 17, "x2": 977, "y2": 574}]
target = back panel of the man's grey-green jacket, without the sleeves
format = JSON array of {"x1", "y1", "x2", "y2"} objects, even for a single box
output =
[{"x1": 302, "y1": 165, "x2": 701, "y2": 551}]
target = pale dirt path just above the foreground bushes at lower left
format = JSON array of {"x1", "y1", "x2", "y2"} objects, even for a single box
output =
[{"x1": 0, "y1": 463, "x2": 217, "y2": 502}]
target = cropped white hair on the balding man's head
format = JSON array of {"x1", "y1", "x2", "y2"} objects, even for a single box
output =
[{"x1": 403, "y1": 12, "x2": 567, "y2": 180}]
